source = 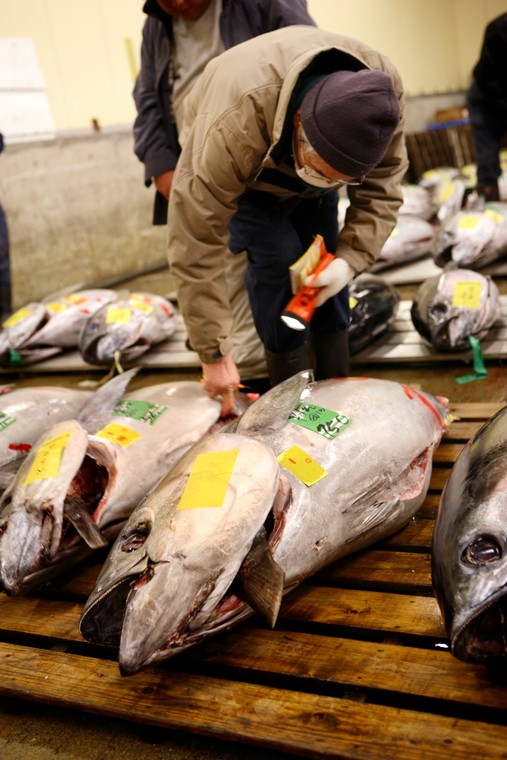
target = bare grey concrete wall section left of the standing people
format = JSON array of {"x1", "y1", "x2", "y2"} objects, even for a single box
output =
[{"x1": 0, "y1": 129, "x2": 167, "y2": 308}]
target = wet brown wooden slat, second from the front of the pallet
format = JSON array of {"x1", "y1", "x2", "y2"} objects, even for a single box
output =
[{"x1": 201, "y1": 629, "x2": 507, "y2": 709}]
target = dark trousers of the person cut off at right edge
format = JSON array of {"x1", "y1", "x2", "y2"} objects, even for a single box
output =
[{"x1": 467, "y1": 82, "x2": 507, "y2": 185}]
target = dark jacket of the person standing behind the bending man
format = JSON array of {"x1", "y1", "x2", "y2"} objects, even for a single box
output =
[{"x1": 133, "y1": 0, "x2": 315, "y2": 224}]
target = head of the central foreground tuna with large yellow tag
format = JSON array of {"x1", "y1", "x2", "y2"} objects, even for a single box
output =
[{"x1": 80, "y1": 432, "x2": 283, "y2": 674}]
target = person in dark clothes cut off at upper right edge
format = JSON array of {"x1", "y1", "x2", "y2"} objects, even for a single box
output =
[{"x1": 467, "y1": 13, "x2": 507, "y2": 201}]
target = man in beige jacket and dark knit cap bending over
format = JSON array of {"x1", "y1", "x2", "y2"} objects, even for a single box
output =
[{"x1": 168, "y1": 26, "x2": 408, "y2": 413}]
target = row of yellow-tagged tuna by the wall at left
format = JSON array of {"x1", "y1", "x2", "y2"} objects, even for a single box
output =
[{"x1": 0, "y1": 288, "x2": 176, "y2": 368}]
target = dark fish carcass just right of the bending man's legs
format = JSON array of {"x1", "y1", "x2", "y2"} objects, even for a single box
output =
[{"x1": 348, "y1": 272, "x2": 400, "y2": 356}]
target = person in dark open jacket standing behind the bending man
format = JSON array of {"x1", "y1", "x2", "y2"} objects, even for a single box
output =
[{"x1": 133, "y1": 0, "x2": 315, "y2": 390}]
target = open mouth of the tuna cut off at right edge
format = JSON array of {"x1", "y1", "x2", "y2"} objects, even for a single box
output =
[{"x1": 451, "y1": 586, "x2": 507, "y2": 663}]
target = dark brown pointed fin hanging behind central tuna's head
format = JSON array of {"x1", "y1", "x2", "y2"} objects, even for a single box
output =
[{"x1": 234, "y1": 529, "x2": 285, "y2": 628}]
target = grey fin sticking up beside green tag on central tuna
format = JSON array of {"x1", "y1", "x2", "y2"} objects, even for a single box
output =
[{"x1": 237, "y1": 369, "x2": 314, "y2": 435}]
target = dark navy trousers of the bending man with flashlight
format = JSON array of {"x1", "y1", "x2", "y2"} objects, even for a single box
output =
[{"x1": 229, "y1": 191, "x2": 350, "y2": 353}]
